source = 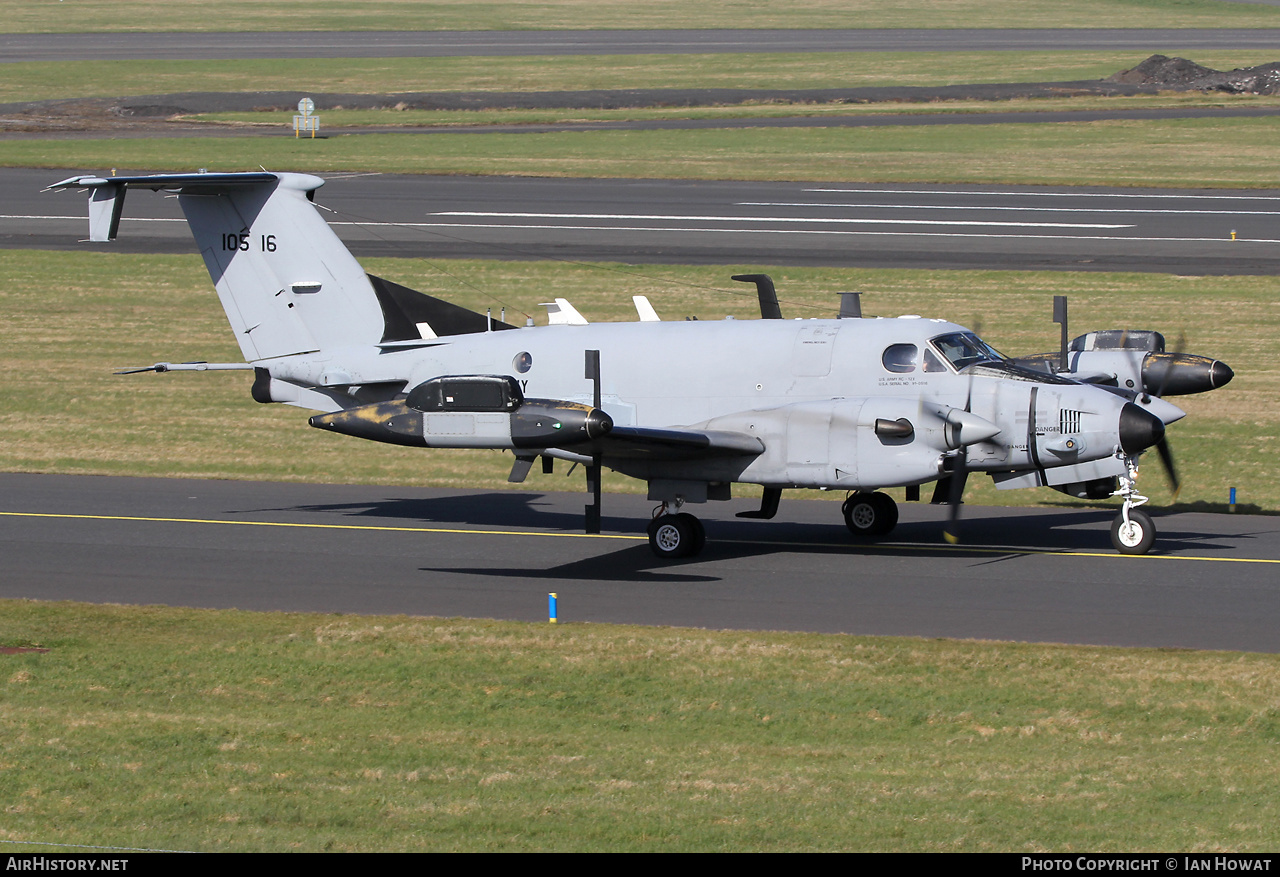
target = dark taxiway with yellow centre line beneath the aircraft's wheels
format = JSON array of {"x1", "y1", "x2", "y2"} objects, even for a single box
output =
[{"x1": 0, "y1": 475, "x2": 1280, "y2": 652}]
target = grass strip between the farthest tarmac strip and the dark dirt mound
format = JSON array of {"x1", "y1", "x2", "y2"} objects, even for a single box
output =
[{"x1": 0, "y1": 51, "x2": 1275, "y2": 101}]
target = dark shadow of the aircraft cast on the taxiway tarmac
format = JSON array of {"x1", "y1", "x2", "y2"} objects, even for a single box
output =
[{"x1": 249, "y1": 490, "x2": 1249, "y2": 563}]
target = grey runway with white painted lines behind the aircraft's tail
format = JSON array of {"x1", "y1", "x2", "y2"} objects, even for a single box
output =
[{"x1": 10, "y1": 168, "x2": 1280, "y2": 274}]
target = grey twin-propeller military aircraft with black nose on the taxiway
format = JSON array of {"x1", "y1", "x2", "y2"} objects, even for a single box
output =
[{"x1": 50, "y1": 172, "x2": 1231, "y2": 558}]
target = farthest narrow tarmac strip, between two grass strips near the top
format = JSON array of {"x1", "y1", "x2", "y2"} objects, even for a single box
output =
[{"x1": 0, "y1": 28, "x2": 1280, "y2": 63}]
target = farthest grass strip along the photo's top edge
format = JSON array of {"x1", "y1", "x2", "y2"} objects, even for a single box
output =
[{"x1": 5, "y1": 0, "x2": 1280, "y2": 33}]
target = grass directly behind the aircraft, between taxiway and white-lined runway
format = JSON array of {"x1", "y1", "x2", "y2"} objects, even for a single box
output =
[{"x1": 0, "y1": 251, "x2": 1280, "y2": 511}]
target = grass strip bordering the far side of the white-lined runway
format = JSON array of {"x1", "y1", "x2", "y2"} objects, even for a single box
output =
[{"x1": 10, "y1": 119, "x2": 1280, "y2": 188}]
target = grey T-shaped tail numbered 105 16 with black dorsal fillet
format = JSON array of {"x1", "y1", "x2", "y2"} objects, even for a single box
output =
[{"x1": 50, "y1": 172, "x2": 476, "y2": 362}]
